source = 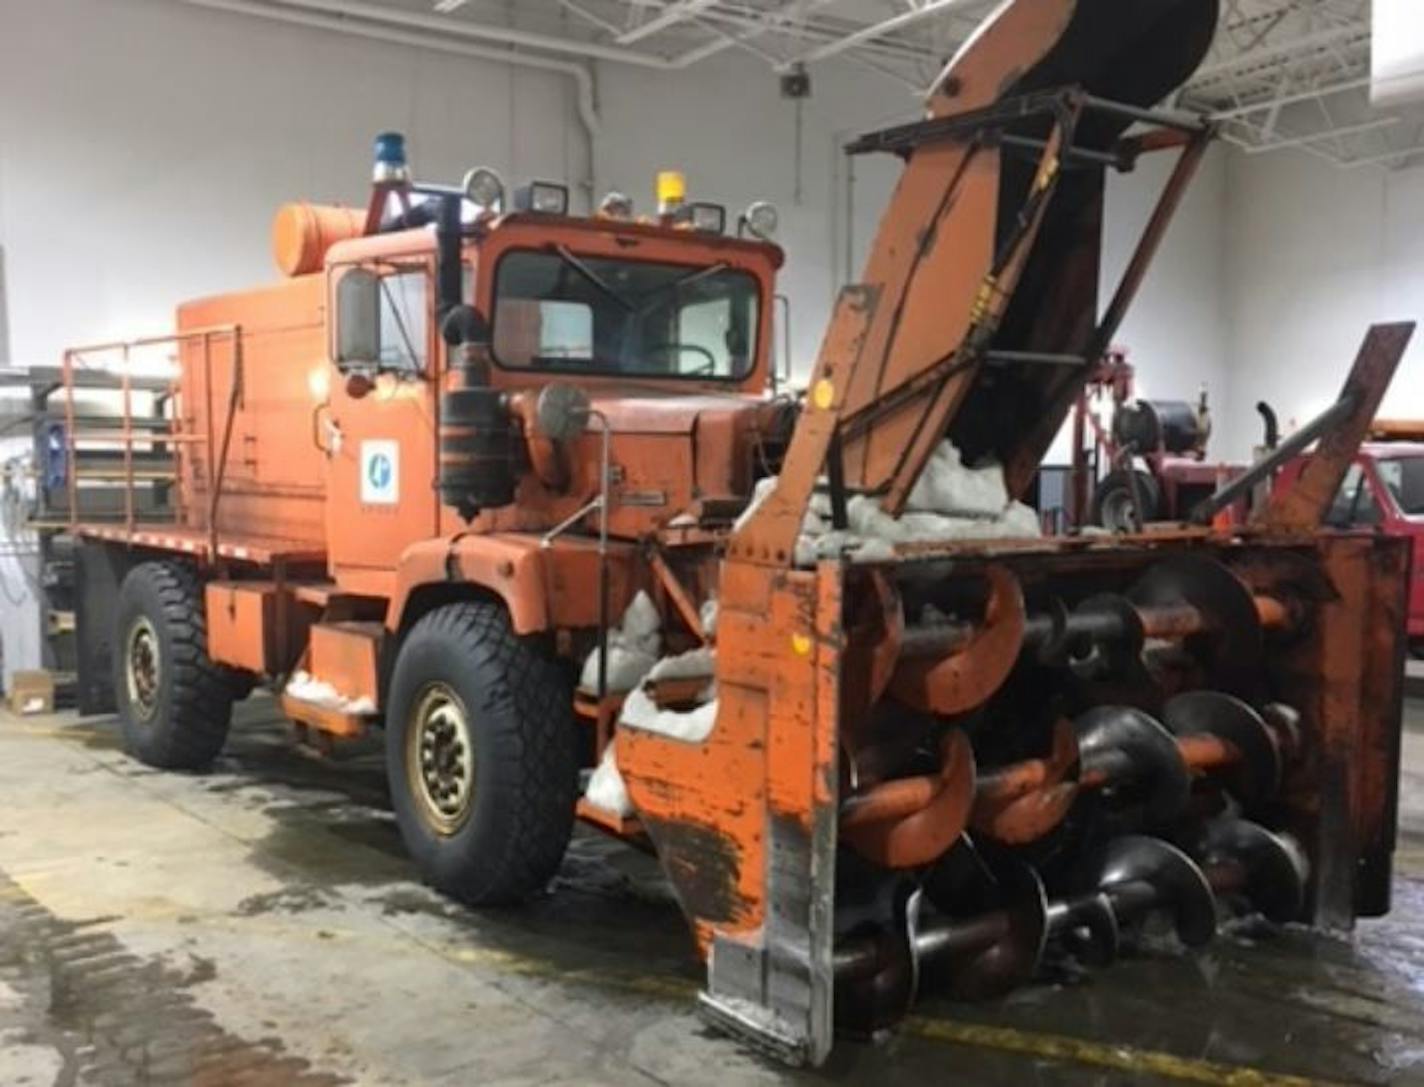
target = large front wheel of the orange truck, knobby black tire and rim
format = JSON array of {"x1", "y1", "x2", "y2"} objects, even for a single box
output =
[{"x1": 386, "y1": 601, "x2": 578, "y2": 906}]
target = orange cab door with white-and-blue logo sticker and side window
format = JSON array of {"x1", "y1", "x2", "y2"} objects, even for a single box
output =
[{"x1": 319, "y1": 256, "x2": 440, "y2": 591}]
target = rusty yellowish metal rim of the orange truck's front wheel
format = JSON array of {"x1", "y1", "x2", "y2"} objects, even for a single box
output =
[{"x1": 406, "y1": 682, "x2": 474, "y2": 836}]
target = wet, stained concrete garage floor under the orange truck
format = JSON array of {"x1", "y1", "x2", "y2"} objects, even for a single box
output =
[{"x1": 0, "y1": 701, "x2": 1424, "y2": 1087}]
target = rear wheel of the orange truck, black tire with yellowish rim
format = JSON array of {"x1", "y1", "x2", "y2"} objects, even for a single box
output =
[{"x1": 114, "y1": 563, "x2": 232, "y2": 769}]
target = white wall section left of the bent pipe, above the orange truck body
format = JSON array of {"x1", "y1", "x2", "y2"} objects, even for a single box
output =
[{"x1": 0, "y1": 0, "x2": 585, "y2": 365}]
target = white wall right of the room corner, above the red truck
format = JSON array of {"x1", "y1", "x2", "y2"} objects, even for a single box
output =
[{"x1": 1226, "y1": 152, "x2": 1424, "y2": 456}]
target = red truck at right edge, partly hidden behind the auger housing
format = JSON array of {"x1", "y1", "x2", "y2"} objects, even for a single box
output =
[{"x1": 1274, "y1": 430, "x2": 1424, "y2": 658}]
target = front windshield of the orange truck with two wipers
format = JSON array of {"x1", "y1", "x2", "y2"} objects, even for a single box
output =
[{"x1": 493, "y1": 248, "x2": 759, "y2": 379}]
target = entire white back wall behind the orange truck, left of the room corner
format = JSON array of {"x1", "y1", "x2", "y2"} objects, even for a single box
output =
[{"x1": 0, "y1": 0, "x2": 1226, "y2": 672}]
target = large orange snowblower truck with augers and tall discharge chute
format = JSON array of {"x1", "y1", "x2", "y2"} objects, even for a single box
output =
[{"x1": 66, "y1": 0, "x2": 1413, "y2": 1063}]
